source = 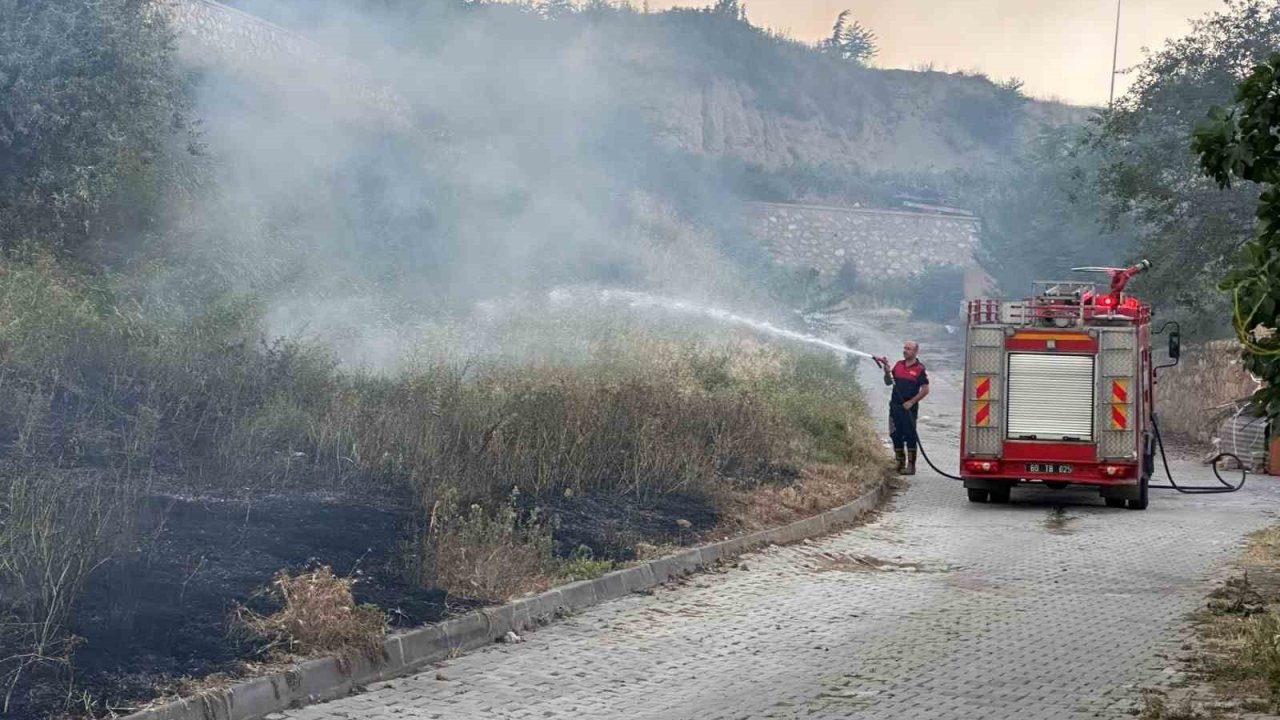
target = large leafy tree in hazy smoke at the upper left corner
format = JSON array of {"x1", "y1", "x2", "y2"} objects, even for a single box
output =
[{"x1": 0, "y1": 0, "x2": 186, "y2": 249}]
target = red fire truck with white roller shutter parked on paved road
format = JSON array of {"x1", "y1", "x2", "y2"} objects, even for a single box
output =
[{"x1": 960, "y1": 260, "x2": 1180, "y2": 510}]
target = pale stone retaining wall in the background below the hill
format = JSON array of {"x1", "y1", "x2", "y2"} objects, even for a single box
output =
[{"x1": 749, "y1": 202, "x2": 982, "y2": 286}]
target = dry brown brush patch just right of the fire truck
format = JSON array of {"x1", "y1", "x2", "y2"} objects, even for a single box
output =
[{"x1": 1156, "y1": 340, "x2": 1258, "y2": 445}]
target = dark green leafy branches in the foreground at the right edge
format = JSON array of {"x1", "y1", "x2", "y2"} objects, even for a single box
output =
[{"x1": 1192, "y1": 54, "x2": 1280, "y2": 418}]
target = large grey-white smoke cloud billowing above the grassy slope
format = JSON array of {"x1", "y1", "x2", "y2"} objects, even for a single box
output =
[{"x1": 160, "y1": 0, "x2": 753, "y2": 368}]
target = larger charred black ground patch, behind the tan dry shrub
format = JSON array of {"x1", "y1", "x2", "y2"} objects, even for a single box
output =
[{"x1": 45, "y1": 497, "x2": 475, "y2": 716}]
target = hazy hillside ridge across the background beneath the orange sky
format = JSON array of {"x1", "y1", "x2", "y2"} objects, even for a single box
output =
[{"x1": 212, "y1": 0, "x2": 1089, "y2": 181}]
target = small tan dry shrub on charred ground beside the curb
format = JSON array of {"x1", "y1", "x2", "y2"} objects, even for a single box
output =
[{"x1": 233, "y1": 566, "x2": 387, "y2": 660}]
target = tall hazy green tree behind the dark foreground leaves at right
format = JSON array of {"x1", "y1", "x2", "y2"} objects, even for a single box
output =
[{"x1": 1093, "y1": 0, "x2": 1280, "y2": 327}]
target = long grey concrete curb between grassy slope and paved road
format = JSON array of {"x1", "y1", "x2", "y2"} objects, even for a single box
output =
[{"x1": 124, "y1": 480, "x2": 892, "y2": 720}]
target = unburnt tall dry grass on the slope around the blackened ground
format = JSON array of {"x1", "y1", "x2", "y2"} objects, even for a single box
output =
[{"x1": 0, "y1": 258, "x2": 884, "y2": 707}]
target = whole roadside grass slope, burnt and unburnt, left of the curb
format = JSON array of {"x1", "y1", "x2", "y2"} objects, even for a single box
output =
[{"x1": 0, "y1": 258, "x2": 887, "y2": 717}]
